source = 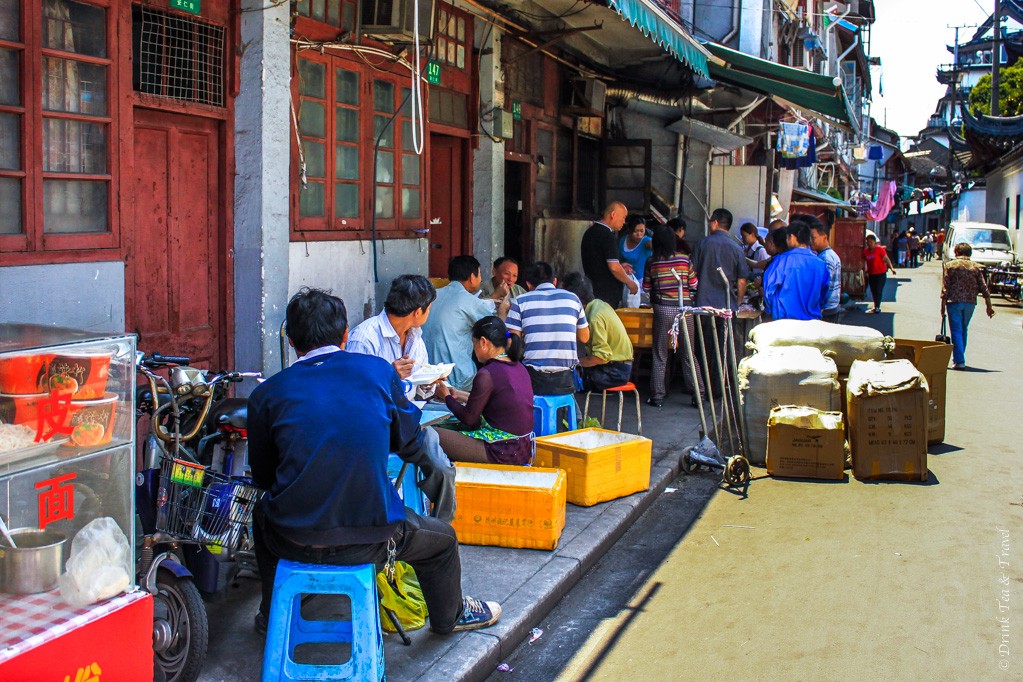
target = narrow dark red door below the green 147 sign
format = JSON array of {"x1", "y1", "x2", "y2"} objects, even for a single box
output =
[{"x1": 430, "y1": 135, "x2": 465, "y2": 277}]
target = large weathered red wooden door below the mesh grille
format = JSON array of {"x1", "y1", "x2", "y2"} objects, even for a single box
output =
[{"x1": 125, "y1": 108, "x2": 226, "y2": 368}]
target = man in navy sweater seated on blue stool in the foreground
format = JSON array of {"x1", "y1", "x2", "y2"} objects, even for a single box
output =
[{"x1": 249, "y1": 288, "x2": 501, "y2": 634}]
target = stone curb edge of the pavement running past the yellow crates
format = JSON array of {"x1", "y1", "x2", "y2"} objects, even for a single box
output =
[{"x1": 415, "y1": 445, "x2": 680, "y2": 682}]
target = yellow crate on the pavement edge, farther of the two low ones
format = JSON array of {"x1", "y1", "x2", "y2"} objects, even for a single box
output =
[{"x1": 535, "y1": 428, "x2": 653, "y2": 507}]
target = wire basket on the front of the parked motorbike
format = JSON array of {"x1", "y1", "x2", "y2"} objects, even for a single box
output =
[{"x1": 157, "y1": 457, "x2": 263, "y2": 553}]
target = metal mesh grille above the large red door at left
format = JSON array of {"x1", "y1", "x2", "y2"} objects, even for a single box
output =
[{"x1": 132, "y1": 5, "x2": 225, "y2": 106}]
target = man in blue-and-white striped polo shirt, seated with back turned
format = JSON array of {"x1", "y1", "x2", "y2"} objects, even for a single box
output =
[{"x1": 506, "y1": 262, "x2": 589, "y2": 396}]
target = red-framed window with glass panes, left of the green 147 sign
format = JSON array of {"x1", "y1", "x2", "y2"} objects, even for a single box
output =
[{"x1": 296, "y1": 54, "x2": 422, "y2": 231}]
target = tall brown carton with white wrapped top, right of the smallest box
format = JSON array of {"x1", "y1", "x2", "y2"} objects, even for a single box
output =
[{"x1": 847, "y1": 360, "x2": 928, "y2": 481}]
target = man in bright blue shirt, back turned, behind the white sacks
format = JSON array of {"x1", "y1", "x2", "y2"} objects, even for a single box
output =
[{"x1": 763, "y1": 216, "x2": 829, "y2": 320}]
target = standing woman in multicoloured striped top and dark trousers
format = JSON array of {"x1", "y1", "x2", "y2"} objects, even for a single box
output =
[{"x1": 642, "y1": 225, "x2": 703, "y2": 407}]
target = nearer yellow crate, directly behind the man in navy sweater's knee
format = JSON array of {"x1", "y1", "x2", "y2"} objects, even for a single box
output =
[{"x1": 452, "y1": 462, "x2": 566, "y2": 549}]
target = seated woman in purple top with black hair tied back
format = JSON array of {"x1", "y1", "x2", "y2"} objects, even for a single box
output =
[{"x1": 434, "y1": 315, "x2": 533, "y2": 465}]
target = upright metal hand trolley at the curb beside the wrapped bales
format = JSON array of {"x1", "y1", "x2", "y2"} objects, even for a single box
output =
[{"x1": 669, "y1": 268, "x2": 750, "y2": 488}]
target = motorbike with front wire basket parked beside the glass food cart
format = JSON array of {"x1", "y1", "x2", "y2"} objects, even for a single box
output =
[{"x1": 135, "y1": 354, "x2": 262, "y2": 682}]
